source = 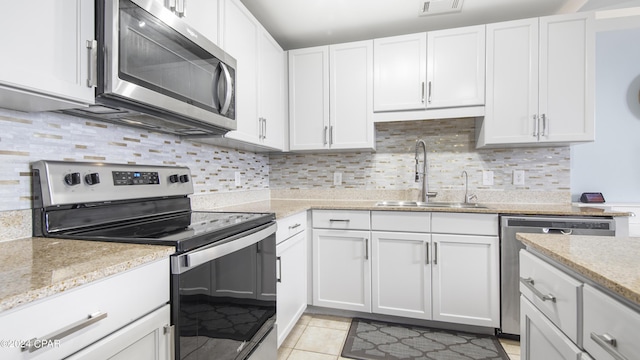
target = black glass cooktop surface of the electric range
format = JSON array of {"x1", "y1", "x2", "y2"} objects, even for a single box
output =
[{"x1": 55, "y1": 211, "x2": 275, "y2": 252}]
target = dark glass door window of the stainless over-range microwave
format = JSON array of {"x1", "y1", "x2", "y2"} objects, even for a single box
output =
[{"x1": 119, "y1": 0, "x2": 235, "y2": 117}]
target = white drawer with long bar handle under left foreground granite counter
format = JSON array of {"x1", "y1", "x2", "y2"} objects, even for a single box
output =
[{"x1": 0, "y1": 258, "x2": 169, "y2": 359}]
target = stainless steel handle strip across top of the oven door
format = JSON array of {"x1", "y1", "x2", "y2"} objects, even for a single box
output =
[{"x1": 171, "y1": 223, "x2": 276, "y2": 274}]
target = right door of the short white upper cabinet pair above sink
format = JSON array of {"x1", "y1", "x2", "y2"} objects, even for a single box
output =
[{"x1": 427, "y1": 25, "x2": 485, "y2": 108}]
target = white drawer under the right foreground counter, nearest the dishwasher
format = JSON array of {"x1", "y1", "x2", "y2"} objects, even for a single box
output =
[{"x1": 520, "y1": 250, "x2": 582, "y2": 345}]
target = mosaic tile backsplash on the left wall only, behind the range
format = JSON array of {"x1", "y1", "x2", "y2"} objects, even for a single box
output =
[{"x1": 0, "y1": 109, "x2": 269, "y2": 211}]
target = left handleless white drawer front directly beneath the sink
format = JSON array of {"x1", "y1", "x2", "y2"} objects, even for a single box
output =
[{"x1": 371, "y1": 211, "x2": 431, "y2": 232}]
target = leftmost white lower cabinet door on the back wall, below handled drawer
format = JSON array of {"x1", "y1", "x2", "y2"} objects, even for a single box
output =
[{"x1": 313, "y1": 229, "x2": 371, "y2": 312}]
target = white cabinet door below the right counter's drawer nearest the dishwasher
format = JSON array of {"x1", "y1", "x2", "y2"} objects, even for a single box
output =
[{"x1": 520, "y1": 296, "x2": 582, "y2": 360}]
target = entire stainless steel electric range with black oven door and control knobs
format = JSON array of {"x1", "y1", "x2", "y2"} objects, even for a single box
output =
[{"x1": 32, "y1": 161, "x2": 276, "y2": 360}]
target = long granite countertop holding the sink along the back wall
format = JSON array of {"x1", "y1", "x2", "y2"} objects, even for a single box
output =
[{"x1": 216, "y1": 199, "x2": 630, "y2": 219}]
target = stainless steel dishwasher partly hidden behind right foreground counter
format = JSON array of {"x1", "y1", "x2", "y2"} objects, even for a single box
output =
[{"x1": 499, "y1": 216, "x2": 616, "y2": 337}]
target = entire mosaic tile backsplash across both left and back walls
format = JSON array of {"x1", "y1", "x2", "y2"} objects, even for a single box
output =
[{"x1": 0, "y1": 109, "x2": 570, "y2": 211}]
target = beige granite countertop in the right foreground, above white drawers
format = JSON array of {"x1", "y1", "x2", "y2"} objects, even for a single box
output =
[{"x1": 516, "y1": 233, "x2": 640, "y2": 306}]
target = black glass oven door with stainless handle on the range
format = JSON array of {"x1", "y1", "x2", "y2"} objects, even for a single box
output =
[{"x1": 171, "y1": 223, "x2": 276, "y2": 360}]
